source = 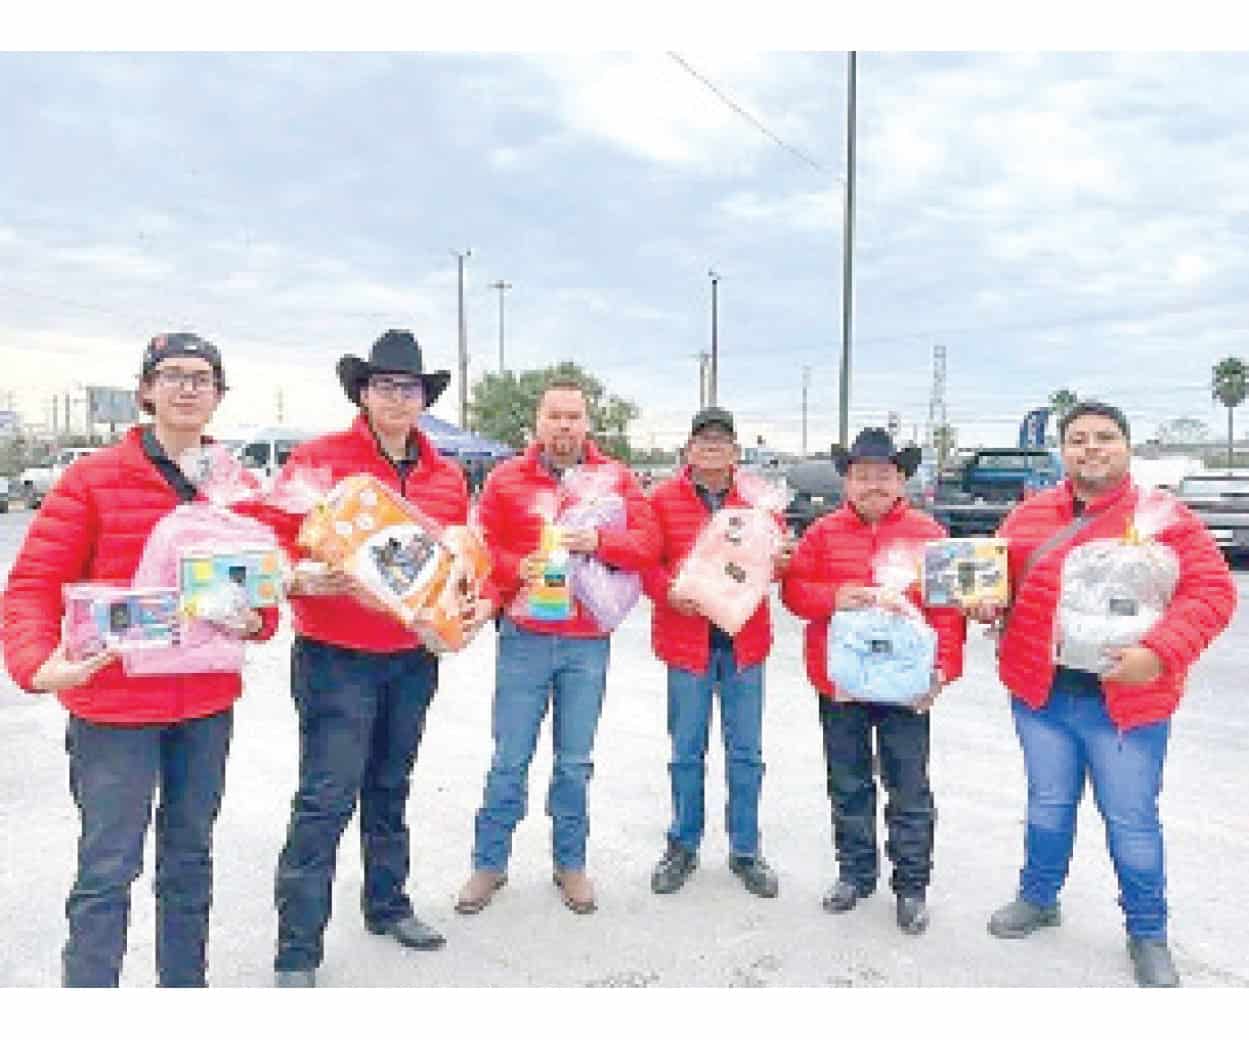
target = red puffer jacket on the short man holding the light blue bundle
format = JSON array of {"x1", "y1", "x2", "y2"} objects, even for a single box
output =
[{"x1": 781, "y1": 501, "x2": 967, "y2": 699}]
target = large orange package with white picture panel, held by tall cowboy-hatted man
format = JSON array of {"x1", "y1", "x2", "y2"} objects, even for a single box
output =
[{"x1": 299, "y1": 473, "x2": 451, "y2": 627}]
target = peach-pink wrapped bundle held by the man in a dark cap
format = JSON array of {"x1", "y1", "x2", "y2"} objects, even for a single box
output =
[{"x1": 672, "y1": 471, "x2": 791, "y2": 635}]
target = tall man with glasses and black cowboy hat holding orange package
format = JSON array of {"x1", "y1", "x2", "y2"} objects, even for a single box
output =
[{"x1": 254, "y1": 330, "x2": 487, "y2": 986}]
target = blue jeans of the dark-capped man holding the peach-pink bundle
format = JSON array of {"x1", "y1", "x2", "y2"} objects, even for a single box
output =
[{"x1": 668, "y1": 647, "x2": 763, "y2": 858}]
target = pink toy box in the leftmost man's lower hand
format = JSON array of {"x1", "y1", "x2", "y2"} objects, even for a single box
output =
[{"x1": 64, "y1": 582, "x2": 181, "y2": 660}]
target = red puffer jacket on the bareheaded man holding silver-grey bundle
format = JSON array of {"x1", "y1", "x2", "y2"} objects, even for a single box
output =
[{"x1": 998, "y1": 477, "x2": 1237, "y2": 729}]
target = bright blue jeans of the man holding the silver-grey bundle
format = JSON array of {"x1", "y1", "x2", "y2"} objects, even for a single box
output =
[{"x1": 1010, "y1": 668, "x2": 1170, "y2": 939}]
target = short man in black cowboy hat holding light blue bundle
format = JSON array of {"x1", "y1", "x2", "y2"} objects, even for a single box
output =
[{"x1": 782, "y1": 427, "x2": 967, "y2": 935}]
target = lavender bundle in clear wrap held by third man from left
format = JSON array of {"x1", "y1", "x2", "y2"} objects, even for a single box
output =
[{"x1": 560, "y1": 466, "x2": 642, "y2": 632}]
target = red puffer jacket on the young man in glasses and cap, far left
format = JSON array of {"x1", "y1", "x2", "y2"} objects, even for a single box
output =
[{"x1": 4, "y1": 426, "x2": 277, "y2": 724}]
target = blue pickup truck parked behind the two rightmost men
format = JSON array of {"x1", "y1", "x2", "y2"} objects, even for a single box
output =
[{"x1": 931, "y1": 448, "x2": 1063, "y2": 538}]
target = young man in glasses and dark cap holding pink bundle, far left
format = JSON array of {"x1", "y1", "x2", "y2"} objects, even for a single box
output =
[{"x1": 4, "y1": 332, "x2": 277, "y2": 986}]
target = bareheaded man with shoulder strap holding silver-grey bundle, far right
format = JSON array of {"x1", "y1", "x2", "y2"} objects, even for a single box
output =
[{"x1": 977, "y1": 401, "x2": 1237, "y2": 986}]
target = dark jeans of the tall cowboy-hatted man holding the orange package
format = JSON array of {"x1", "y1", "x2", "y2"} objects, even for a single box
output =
[{"x1": 274, "y1": 637, "x2": 438, "y2": 971}]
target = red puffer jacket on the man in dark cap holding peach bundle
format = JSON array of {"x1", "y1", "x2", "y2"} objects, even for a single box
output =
[{"x1": 642, "y1": 466, "x2": 779, "y2": 675}]
